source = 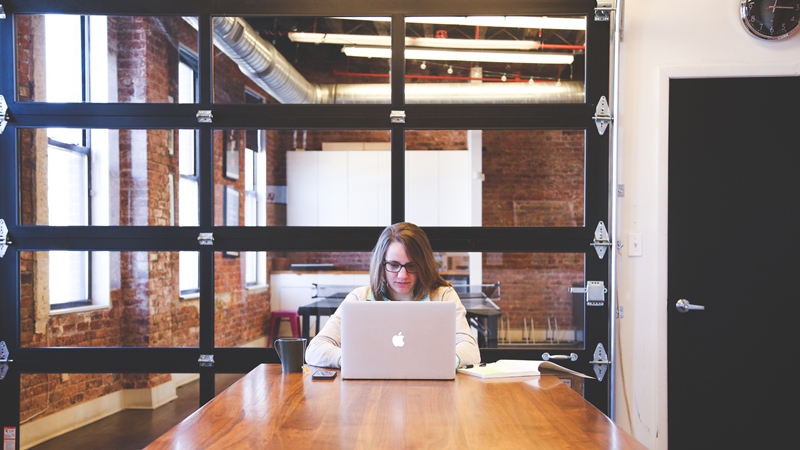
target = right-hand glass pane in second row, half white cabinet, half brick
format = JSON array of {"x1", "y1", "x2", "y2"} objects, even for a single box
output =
[{"x1": 404, "y1": 130, "x2": 585, "y2": 227}]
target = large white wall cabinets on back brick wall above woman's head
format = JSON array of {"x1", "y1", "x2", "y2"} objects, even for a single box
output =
[{"x1": 286, "y1": 150, "x2": 472, "y2": 226}]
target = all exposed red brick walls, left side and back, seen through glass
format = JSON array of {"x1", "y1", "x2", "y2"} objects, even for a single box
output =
[{"x1": 16, "y1": 16, "x2": 584, "y2": 421}]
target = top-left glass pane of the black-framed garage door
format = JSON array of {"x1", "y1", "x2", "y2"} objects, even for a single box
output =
[{"x1": 15, "y1": 15, "x2": 197, "y2": 103}]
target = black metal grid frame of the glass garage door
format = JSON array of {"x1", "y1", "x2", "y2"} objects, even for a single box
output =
[{"x1": 0, "y1": 0, "x2": 613, "y2": 432}]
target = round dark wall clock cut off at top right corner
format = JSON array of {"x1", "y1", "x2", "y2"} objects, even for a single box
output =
[{"x1": 740, "y1": 0, "x2": 800, "y2": 41}]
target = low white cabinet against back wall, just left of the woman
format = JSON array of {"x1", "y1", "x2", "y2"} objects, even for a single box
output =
[{"x1": 270, "y1": 273, "x2": 369, "y2": 336}]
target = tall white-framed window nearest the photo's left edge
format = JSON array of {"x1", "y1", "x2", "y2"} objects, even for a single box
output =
[{"x1": 44, "y1": 15, "x2": 114, "y2": 315}]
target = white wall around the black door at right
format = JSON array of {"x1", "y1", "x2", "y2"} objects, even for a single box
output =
[{"x1": 612, "y1": 0, "x2": 800, "y2": 449}]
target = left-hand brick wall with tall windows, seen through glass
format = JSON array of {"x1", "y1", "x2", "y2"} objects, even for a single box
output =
[{"x1": 17, "y1": 16, "x2": 270, "y2": 421}]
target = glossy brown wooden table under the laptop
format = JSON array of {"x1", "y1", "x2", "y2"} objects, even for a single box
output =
[{"x1": 147, "y1": 364, "x2": 645, "y2": 450}]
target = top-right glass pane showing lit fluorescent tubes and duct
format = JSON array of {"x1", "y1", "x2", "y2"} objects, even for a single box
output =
[{"x1": 404, "y1": 16, "x2": 586, "y2": 103}]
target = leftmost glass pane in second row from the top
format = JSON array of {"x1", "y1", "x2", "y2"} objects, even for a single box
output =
[{"x1": 18, "y1": 129, "x2": 198, "y2": 226}]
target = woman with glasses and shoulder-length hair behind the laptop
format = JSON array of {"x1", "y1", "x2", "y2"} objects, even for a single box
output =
[{"x1": 306, "y1": 222, "x2": 481, "y2": 368}]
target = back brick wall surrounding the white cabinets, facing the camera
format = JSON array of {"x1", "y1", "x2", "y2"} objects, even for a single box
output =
[{"x1": 276, "y1": 126, "x2": 585, "y2": 332}]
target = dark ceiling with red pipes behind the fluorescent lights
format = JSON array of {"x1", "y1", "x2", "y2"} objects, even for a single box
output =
[{"x1": 245, "y1": 17, "x2": 586, "y2": 83}]
